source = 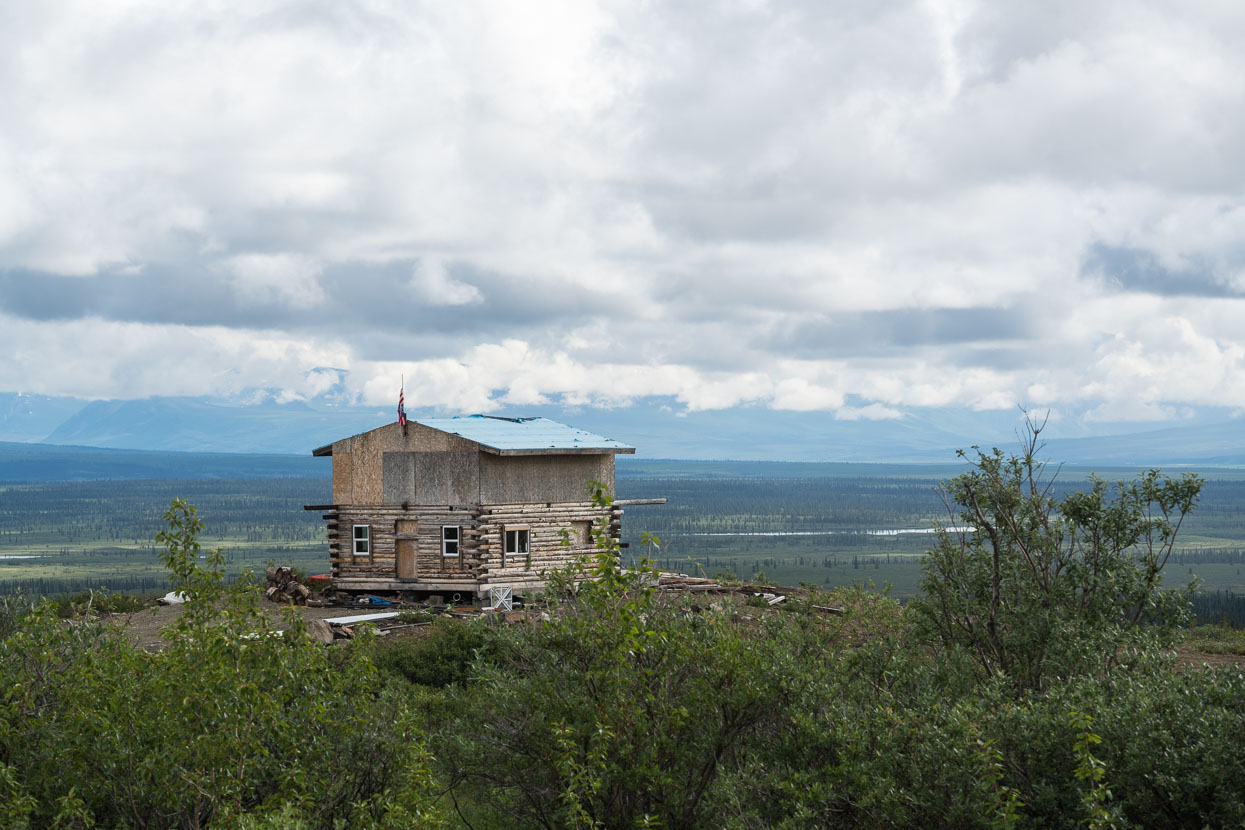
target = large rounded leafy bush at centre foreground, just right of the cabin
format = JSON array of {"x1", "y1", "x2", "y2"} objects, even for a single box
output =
[{"x1": 437, "y1": 555, "x2": 792, "y2": 828}]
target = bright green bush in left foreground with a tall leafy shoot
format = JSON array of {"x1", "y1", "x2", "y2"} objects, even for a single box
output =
[{"x1": 0, "y1": 501, "x2": 450, "y2": 828}]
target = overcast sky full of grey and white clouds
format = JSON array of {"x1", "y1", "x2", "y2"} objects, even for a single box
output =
[{"x1": 0, "y1": 0, "x2": 1245, "y2": 421}]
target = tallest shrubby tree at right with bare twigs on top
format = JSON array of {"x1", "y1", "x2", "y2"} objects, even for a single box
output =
[{"x1": 914, "y1": 419, "x2": 1203, "y2": 689}]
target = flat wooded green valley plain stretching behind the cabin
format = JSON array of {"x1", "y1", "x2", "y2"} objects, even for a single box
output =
[{"x1": 7, "y1": 465, "x2": 1245, "y2": 625}]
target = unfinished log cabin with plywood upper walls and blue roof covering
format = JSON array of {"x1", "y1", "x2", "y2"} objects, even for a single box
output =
[{"x1": 305, "y1": 414, "x2": 665, "y2": 597}]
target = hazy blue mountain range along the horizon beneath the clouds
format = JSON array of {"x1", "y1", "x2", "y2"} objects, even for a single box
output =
[{"x1": 0, "y1": 394, "x2": 1245, "y2": 467}]
